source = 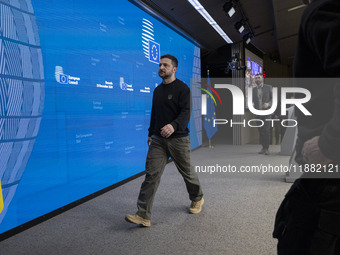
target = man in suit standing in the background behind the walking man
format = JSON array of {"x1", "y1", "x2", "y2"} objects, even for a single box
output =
[{"x1": 253, "y1": 74, "x2": 273, "y2": 155}]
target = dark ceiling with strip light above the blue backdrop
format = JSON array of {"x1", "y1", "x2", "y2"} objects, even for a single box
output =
[{"x1": 135, "y1": 0, "x2": 305, "y2": 64}]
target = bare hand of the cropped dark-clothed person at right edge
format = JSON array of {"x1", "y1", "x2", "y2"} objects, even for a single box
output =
[{"x1": 302, "y1": 136, "x2": 332, "y2": 165}]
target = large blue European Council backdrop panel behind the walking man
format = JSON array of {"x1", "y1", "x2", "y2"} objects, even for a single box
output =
[{"x1": 0, "y1": 0, "x2": 202, "y2": 233}]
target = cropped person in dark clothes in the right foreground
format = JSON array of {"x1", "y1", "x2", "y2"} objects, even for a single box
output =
[{"x1": 273, "y1": 0, "x2": 340, "y2": 255}]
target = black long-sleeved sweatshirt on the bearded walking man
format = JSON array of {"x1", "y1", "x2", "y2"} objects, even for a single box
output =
[{"x1": 149, "y1": 79, "x2": 190, "y2": 137}]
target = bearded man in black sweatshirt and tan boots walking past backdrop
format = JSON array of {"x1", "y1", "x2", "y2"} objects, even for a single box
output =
[{"x1": 125, "y1": 54, "x2": 204, "y2": 227}]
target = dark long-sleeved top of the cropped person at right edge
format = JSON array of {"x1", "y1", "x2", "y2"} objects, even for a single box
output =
[{"x1": 294, "y1": 0, "x2": 340, "y2": 163}]
